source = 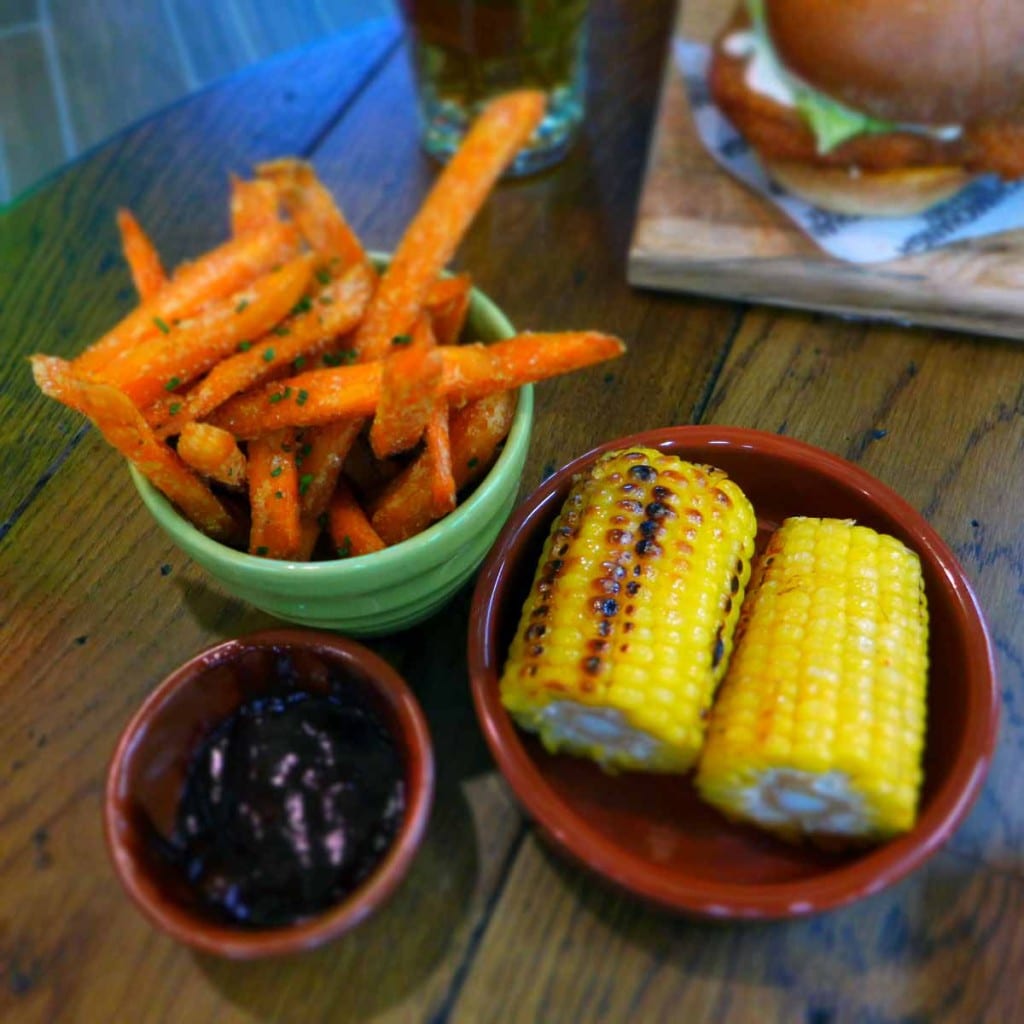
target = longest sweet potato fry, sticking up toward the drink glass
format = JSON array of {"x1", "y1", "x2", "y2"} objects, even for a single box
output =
[{"x1": 355, "y1": 90, "x2": 545, "y2": 359}]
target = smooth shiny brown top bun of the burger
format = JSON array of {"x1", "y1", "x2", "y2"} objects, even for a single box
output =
[{"x1": 765, "y1": 0, "x2": 1024, "y2": 125}]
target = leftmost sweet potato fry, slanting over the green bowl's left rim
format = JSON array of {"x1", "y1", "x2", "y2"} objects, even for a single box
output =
[{"x1": 32, "y1": 355, "x2": 237, "y2": 542}]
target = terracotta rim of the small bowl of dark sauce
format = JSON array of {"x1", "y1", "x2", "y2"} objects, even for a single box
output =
[{"x1": 103, "y1": 627, "x2": 435, "y2": 959}]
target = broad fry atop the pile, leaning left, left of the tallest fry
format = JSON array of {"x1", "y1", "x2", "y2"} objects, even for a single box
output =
[{"x1": 256, "y1": 159, "x2": 370, "y2": 268}]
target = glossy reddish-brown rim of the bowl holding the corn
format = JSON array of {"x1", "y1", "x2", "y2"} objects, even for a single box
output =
[{"x1": 468, "y1": 425, "x2": 999, "y2": 919}]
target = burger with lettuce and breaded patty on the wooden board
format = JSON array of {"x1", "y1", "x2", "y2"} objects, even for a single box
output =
[{"x1": 710, "y1": 0, "x2": 1024, "y2": 216}]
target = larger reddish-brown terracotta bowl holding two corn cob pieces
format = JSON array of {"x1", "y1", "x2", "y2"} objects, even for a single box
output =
[{"x1": 469, "y1": 427, "x2": 998, "y2": 918}]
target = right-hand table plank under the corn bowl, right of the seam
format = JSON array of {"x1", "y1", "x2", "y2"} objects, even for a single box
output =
[{"x1": 454, "y1": 309, "x2": 1024, "y2": 1024}]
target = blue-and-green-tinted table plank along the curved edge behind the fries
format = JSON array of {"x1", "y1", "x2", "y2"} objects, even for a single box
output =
[{"x1": 0, "y1": 23, "x2": 397, "y2": 537}]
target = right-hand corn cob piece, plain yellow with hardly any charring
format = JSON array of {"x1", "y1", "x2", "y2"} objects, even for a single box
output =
[{"x1": 696, "y1": 518, "x2": 928, "y2": 839}]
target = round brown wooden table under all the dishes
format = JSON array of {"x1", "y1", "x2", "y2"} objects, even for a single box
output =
[{"x1": 0, "y1": 0, "x2": 1024, "y2": 1024}]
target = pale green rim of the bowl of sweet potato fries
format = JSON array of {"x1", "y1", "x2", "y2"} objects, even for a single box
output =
[{"x1": 128, "y1": 264, "x2": 534, "y2": 579}]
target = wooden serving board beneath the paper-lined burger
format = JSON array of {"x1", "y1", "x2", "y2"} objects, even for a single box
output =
[{"x1": 628, "y1": 0, "x2": 1024, "y2": 339}]
